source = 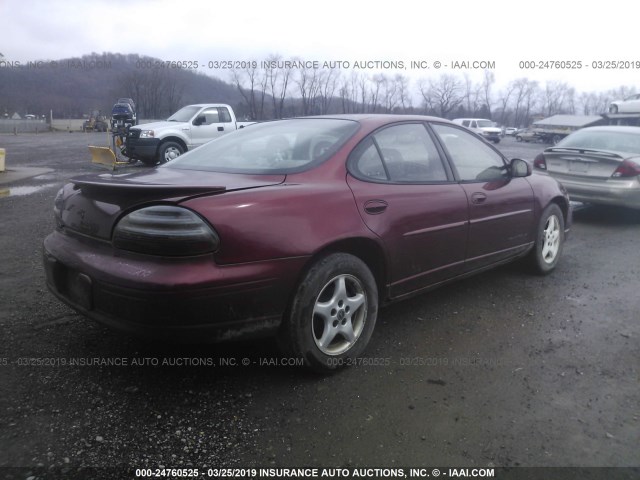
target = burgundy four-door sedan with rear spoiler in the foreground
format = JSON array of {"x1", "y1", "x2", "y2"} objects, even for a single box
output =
[{"x1": 44, "y1": 115, "x2": 571, "y2": 370}]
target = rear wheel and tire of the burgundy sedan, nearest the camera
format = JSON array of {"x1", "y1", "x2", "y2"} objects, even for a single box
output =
[{"x1": 279, "y1": 253, "x2": 378, "y2": 373}]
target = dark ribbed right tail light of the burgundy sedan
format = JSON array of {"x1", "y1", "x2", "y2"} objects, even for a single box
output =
[{"x1": 113, "y1": 205, "x2": 220, "y2": 256}]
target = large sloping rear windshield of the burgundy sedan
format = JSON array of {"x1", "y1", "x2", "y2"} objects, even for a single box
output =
[{"x1": 166, "y1": 118, "x2": 359, "y2": 174}]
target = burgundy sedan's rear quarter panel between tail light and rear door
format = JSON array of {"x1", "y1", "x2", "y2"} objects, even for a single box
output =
[{"x1": 183, "y1": 178, "x2": 375, "y2": 264}]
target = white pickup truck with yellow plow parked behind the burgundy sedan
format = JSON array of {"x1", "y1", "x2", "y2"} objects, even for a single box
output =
[{"x1": 126, "y1": 103, "x2": 253, "y2": 165}]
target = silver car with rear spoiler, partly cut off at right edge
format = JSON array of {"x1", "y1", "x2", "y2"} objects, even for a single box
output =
[{"x1": 533, "y1": 126, "x2": 640, "y2": 209}]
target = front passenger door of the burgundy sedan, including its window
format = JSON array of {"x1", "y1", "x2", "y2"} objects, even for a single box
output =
[{"x1": 432, "y1": 123, "x2": 534, "y2": 272}]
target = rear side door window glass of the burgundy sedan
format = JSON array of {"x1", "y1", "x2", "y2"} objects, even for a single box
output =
[{"x1": 350, "y1": 124, "x2": 447, "y2": 183}]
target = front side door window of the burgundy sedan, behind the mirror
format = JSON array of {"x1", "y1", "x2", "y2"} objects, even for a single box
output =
[{"x1": 433, "y1": 124, "x2": 508, "y2": 182}]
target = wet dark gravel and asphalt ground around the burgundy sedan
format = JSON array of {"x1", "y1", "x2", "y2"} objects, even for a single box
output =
[{"x1": 0, "y1": 133, "x2": 640, "y2": 479}]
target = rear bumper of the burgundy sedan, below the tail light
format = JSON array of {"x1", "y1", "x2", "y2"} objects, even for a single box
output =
[{"x1": 43, "y1": 232, "x2": 305, "y2": 343}]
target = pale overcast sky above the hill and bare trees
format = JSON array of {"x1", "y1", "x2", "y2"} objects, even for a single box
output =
[{"x1": 0, "y1": 0, "x2": 640, "y2": 92}]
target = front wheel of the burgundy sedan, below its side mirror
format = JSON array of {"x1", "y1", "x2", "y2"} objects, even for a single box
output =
[{"x1": 530, "y1": 203, "x2": 564, "y2": 275}]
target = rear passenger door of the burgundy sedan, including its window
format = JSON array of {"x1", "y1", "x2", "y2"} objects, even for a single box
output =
[{"x1": 347, "y1": 123, "x2": 468, "y2": 297}]
